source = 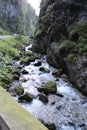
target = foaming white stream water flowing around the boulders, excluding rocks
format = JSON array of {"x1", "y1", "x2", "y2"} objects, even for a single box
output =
[{"x1": 15, "y1": 46, "x2": 87, "y2": 130}]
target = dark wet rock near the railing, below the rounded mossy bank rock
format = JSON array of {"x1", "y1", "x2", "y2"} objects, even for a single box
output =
[{"x1": 18, "y1": 92, "x2": 33, "y2": 102}]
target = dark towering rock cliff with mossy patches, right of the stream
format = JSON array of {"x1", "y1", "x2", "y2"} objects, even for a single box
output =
[{"x1": 33, "y1": 0, "x2": 87, "y2": 94}]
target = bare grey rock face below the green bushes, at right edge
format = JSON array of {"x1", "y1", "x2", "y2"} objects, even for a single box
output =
[{"x1": 66, "y1": 56, "x2": 87, "y2": 96}]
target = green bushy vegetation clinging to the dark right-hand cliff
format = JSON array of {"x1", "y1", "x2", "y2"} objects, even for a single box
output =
[{"x1": 59, "y1": 21, "x2": 87, "y2": 61}]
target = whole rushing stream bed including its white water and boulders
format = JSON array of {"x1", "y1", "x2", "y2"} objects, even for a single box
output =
[{"x1": 8, "y1": 45, "x2": 87, "y2": 130}]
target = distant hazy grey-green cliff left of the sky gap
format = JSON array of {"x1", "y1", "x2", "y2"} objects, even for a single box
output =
[{"x1": 0, "y1": 0, "x2": 36, "y2": 34}]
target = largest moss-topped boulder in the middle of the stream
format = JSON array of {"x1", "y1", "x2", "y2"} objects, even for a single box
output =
[{"x1": 37, "y1": 81, "x2": 57, "y2": 94}]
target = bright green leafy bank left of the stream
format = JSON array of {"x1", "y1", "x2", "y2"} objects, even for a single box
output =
[{"x1": 0, "y1": 35, "x2": 29, "y2": 88}]
